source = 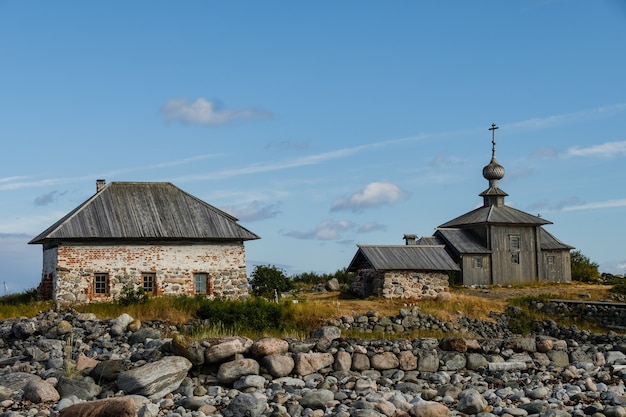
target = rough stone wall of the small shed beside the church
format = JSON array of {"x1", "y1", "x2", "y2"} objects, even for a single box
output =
[{"x1": 352, "y1": 269, "x2": 450, "y2": 299}]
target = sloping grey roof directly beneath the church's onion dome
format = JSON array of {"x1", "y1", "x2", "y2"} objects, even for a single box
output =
[{"x1": 439, "y1": 205, "x2": 552, "y2": 228}]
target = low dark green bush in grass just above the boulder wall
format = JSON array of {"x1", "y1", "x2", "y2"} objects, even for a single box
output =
[{"x1": 196, "y1": 298, "x2": 293, "y2": 331}]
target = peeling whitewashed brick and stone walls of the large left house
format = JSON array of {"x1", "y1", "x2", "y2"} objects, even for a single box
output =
[{"x1": 43, "y1": 244, "x2": 248, "y2": 304}]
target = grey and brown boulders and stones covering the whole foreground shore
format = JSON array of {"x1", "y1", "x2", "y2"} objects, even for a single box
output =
[{"x1": 0, "y1": 310, "x2": 626, "y2": 417}]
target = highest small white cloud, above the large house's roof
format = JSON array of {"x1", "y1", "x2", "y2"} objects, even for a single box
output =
[{"x1": 162, "y1": 97, "x2": 272, "y2": 126}]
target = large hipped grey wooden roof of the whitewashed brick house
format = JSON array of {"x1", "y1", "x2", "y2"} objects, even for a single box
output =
[{"x1": 29, "y1": 182, "x2": 259, "y2": 244}]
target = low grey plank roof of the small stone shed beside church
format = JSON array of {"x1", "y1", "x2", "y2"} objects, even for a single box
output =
[{"x1": 348, "y1": 245, "x2": 460, "y2": 272}]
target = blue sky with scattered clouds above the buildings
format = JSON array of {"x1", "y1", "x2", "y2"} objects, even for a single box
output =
[{"x1": 0, "y1": 0, "x2": 626, "y2": 292}]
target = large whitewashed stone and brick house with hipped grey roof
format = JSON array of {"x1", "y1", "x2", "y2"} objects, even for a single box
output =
[{"x1": 29, "y1": 180, "x2": 259, "y2": 304}]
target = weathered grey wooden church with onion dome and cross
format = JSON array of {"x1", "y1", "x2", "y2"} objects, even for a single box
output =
[{"x1": 348, "y1": 124, "x2": 574, "y2": 296}]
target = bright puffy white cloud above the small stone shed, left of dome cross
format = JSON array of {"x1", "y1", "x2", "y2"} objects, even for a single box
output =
[{"x1": 331, "y1": 182, "x2": 408, "y2": 212}]
